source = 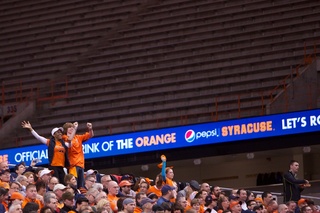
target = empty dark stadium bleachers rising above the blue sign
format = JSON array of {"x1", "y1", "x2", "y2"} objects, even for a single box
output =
[{"x1": 0, "y1": 0, "x2": 320, "y2": 147}]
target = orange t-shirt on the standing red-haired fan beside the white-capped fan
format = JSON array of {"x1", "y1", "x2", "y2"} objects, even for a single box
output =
[{"x1": 62, "y1": 132, "x2": 90, "y2": 168}]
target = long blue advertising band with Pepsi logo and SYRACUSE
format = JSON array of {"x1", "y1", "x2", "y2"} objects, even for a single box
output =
[{"x1": 0, "y1": 109, "x2": 320, "y2": 164}]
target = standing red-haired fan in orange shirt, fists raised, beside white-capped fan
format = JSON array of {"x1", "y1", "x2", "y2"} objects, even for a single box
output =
[{"x1": 62, "y1": 122, "x2": 94, "y2": 188}]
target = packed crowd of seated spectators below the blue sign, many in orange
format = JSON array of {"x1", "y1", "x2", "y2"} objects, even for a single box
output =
[{"x1": 0, "y1": 162, "x2": 319, "y2": 213}]
